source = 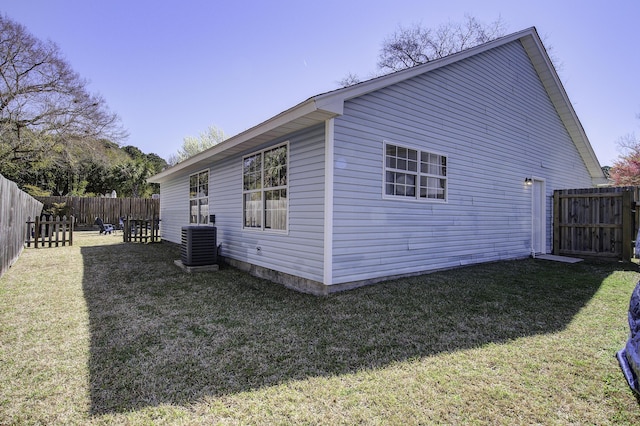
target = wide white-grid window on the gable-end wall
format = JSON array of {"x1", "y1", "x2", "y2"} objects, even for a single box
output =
[{"x1": 384, "y1": 143, "x2": 447, "y2": 201}]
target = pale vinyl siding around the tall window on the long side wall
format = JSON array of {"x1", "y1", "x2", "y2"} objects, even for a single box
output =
[{"x1": 214, "y1": 126, "x2": 324, "y2": 282}]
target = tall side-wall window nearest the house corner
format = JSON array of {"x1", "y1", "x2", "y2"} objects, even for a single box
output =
[{"x1": 242, "y1": 143, "x2": 289, "y2": 231}]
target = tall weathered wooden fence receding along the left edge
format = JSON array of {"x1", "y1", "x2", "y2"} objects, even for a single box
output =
[{"x1": 0, "y1": 175, "x2": 42, "y2": 276}]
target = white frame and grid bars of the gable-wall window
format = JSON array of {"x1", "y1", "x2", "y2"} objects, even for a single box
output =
[{"x1": 382, "y1": 141, "x2": 449, "y2": 203}]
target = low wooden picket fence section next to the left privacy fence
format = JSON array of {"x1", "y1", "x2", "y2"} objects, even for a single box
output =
[{"x1": 25, "y1": 216, "x2": 73, "y2": 248}]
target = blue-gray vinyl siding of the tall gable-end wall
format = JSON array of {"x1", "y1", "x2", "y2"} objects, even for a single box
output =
[{"x1": 332, "y1": 42, "x2": 591, "y2": 284}]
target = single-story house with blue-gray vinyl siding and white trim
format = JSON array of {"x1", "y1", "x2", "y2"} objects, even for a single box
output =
[{"x1": 149, "y1": 28, "x2": 606, "y2": 294}]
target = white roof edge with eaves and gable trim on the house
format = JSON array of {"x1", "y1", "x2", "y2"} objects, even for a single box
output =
[{"x1": 149, "y1": 27, "x2": 606, "y2": 183}]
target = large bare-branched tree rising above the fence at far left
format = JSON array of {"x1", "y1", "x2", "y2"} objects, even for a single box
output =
[{"x1": 0, "y1": 15, "x2": 126, "y2": 180}]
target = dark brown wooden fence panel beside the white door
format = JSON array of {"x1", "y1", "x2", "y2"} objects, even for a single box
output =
[{"x1": 553, "y1": 187, "x2": 638, "y2": 260}]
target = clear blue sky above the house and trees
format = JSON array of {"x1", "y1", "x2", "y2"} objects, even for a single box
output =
[{"x1": 0, "y1": 0, "x2": 640, "y2": 165}]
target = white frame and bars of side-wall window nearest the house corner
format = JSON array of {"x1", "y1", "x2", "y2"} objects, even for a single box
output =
[{"x1": 241, "y1": 141, "x2": 290, "y2": 234}]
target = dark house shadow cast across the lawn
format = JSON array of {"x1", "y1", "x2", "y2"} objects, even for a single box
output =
[{"x1": 82, "y1": 244, "x2": 632, "y2": 414}]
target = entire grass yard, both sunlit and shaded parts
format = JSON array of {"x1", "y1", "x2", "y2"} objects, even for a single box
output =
[{"x1": 0, "y1": 232, "x2": 640, "y2": 425}]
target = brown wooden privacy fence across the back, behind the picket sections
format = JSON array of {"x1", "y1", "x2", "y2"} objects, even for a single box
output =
[{"x1": 36, "y1": 197, "x2": 160, "y2": 226}]
